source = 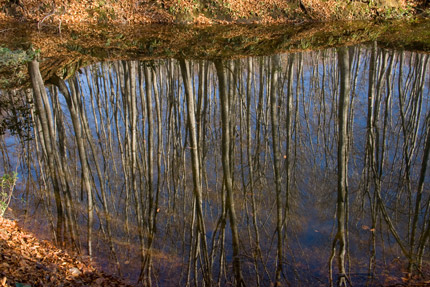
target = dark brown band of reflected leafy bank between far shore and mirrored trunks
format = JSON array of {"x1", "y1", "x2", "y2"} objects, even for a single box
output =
[{"x1": 0, "y1": 19, "x2": 430, "y2": 89}]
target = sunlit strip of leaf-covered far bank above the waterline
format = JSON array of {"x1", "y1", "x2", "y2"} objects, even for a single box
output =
[{"x1": 0, "y1": 0, "x2": 430, "y2": 25}]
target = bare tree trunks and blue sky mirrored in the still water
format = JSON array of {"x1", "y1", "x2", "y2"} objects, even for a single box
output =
[{"x1": 1, "y1": 45, "x2": 430, "y2": 286}]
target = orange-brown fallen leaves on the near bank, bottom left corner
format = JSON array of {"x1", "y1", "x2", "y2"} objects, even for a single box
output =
[{"x1": 0, "y1": 216, "x2": 129, "y2": 287}]
